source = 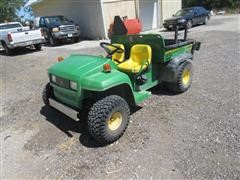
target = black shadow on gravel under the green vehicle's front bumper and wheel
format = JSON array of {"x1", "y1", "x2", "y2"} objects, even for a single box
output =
[{"x1": 40, "y1": 106, "x2": 141, "y2": 148}]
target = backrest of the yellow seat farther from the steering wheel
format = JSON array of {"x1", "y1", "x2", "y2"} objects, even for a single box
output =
[{"x1": 130, "y1": 44, "x2": 152, "y2": 65}]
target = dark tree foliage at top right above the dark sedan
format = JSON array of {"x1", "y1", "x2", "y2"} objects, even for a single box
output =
[{"x1": 183, "y1": 0, "x2": 240, "y2": 9}]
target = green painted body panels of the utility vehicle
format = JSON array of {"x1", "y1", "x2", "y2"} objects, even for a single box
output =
[{"x1": 48, "y1": 34, "x2": 199, "y2": 109}]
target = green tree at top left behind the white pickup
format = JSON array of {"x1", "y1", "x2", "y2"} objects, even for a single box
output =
[{"x1": 0, "y1": 0, "x2": 26, "y2": 23}]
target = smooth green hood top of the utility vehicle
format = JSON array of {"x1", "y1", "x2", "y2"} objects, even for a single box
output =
[{"x1": 48, "y1": 55, "x2": 115, "y2": 81}]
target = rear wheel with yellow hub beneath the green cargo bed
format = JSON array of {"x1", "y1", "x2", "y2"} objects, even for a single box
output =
[{"x1": 167, "y1": 61, "x2": 193, "y2": 93}]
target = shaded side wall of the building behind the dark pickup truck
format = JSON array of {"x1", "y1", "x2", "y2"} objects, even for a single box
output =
[{"x1": 33, "y1": 0, "x2": 105, "y2": 39}]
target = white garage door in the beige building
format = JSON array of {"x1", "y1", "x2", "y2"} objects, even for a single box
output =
[{"x1": 139, "y1": 0, "x2": 159, "y2": 31}]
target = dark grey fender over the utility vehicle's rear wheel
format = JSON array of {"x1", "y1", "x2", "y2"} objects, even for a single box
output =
[{"x1": 159, "y1": 53, "x2": 193, "y2": 82}]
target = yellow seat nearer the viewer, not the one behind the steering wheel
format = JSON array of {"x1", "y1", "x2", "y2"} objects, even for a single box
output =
[{"x1": 118, "y1": 44, "x2": 152, "y2": 73}]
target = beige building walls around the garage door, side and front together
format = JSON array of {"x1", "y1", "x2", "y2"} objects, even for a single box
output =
[{"x1": 32, "y1": 0, "x2": 182, "y2": 39}]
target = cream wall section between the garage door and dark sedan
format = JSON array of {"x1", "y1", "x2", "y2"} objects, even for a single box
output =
[{"x1": 161, "y1": 0, "x2": 182, "y2": 20}]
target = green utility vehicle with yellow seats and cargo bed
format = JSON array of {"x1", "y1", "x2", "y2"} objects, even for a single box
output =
[{"x1": 43, "y1": 18, "x2": 200, "y2": 144}]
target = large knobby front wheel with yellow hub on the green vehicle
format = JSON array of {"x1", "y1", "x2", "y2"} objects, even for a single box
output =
[{"x1": 88, "y1": 95, "x2": 130, "y2": 144}]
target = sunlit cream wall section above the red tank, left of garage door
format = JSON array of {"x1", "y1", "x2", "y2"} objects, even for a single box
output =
[{"x1": 102, "y1": 0, "x2": 136, "y2": 34}]
